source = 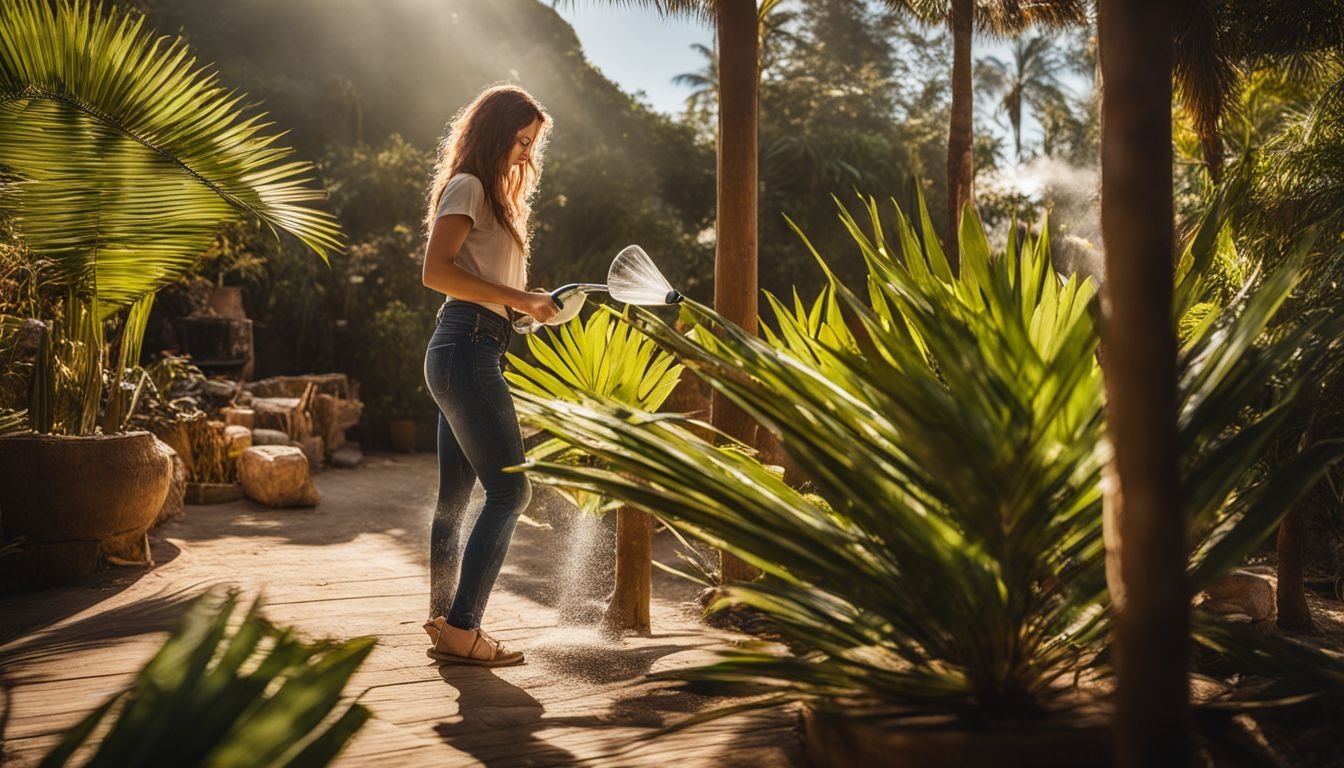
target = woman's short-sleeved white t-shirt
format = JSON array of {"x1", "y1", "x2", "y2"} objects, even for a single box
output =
[{"x1": 434, "y1": 174, "x2": 527, "y2": 319}]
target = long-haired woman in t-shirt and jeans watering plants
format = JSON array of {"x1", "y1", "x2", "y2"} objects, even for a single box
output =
[{"x1": 423, "y1": 86, "x2": 558, "y2": 666}]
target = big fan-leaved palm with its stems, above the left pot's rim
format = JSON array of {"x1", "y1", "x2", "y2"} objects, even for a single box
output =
[{"x1": 0, "y1": 0, "x2": 340, "y2": 434}]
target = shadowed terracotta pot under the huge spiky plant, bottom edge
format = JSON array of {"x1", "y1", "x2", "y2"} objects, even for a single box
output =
[{"x1": 802, "y1": 705, "x2": 1113, "y2": 768}]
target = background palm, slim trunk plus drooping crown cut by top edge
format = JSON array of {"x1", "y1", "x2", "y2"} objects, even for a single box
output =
[{"x1": 886, "y1": 0, "x2": 1087, "y2": 270}]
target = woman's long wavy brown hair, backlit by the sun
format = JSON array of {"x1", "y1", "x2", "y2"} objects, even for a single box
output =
[{"x1": 425, "y1": 85, "x2": 551, "y2": 253}]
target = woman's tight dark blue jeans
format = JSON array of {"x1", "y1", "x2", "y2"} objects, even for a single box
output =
[{"x1": 425, "y1": 301, "x2": 532, "y2": 629}]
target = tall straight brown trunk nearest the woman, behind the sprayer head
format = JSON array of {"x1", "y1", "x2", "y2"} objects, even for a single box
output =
[{"x1": 710, "y1": 0, "x2": 761, "y2": 581}]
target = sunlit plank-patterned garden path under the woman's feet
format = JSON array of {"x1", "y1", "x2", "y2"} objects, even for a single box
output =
[{"x1": 0, "y1": 455, "x2": 806, "y2": 768}]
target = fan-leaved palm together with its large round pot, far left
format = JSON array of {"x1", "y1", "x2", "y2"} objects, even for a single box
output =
[{"x1": 0, "y1": 0, "x2": 340, "y2": 580}]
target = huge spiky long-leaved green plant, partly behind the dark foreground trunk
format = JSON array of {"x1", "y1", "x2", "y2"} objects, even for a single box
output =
[{"x1": 510, "y1": 193, "x2": 1344, "y2": 716}]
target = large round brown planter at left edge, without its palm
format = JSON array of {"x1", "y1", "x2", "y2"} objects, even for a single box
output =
[{"x1": 0, "y1": 432, "x2": 172, "y2": 584}]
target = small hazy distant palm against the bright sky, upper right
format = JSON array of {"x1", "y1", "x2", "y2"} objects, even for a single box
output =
[{"x1": 976, "y1": 35, "x2": 1068, "y2": 163}]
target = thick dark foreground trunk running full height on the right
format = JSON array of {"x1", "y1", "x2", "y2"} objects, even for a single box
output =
[{"x1": 1098, "y1": 0, "x2": 1191, "y2": 767}]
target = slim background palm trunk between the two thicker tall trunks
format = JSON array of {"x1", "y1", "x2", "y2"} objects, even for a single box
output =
[{"x1": 943, "y1": 0, "x2": 976, "y2": 272}]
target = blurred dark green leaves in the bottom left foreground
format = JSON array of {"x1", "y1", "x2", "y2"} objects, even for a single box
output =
[{"x1": 40, "y1": 590, "x2": 374, "y2": 768}]
